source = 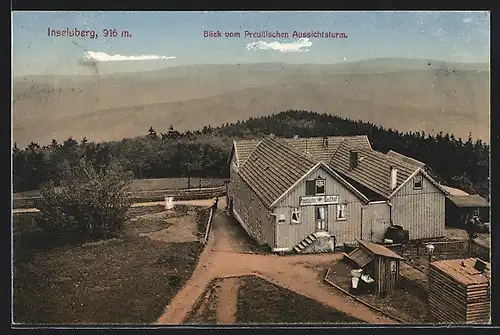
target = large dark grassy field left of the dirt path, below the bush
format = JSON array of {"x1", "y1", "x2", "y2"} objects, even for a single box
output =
[{"x1": 13, "y1": 206, "x2": 209, "y2": 324}]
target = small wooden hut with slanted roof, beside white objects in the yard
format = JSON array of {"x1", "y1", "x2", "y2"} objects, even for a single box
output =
[{"x1": 345, "y1": 240, "x2": 403, "y2": 293}]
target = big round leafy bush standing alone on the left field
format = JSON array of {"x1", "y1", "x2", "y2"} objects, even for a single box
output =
[{"x1": 37, "y1": 159, "x2": 132, "y2": 244}]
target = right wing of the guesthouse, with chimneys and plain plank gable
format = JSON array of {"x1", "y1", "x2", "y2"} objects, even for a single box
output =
[{"x1": 329, "y1": 143, "x2": 446, "y2": 242}]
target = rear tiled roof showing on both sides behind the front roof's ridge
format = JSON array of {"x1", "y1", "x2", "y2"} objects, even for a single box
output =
[{"x1": 231, "y1": 135, "x2": 371, "y2": 166}]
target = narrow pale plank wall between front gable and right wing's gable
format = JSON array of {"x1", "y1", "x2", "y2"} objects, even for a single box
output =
[{"x1": 361, "y1": 202, "x2": 391, "y2": 243}]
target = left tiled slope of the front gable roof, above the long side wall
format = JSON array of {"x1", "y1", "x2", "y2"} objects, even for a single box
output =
[{"x1": 238, "y1": 136, "x2": 316, "y2": 208}]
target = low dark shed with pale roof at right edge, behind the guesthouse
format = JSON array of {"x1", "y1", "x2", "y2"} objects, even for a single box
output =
[{"x1": 442, "y1": 186, "x2": 490, "y2": 227}]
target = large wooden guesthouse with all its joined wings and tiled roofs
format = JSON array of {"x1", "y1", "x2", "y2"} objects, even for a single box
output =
[{"x1": 228, "y1": 136, "x2": 445, "y2": 252}]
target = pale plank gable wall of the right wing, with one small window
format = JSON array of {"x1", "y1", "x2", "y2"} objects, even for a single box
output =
[{"x1": 391, "y1": 175, "x2": 445, "y2": 240}]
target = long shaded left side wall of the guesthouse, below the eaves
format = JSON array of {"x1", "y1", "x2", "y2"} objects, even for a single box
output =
[{"x1": 230, "y1": 173, "x2": 274, "y2": 247}]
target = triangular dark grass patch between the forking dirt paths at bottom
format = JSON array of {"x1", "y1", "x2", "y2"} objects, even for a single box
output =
[{"x1": 186, "y1": 276, "x2": 361, "y2": 324}]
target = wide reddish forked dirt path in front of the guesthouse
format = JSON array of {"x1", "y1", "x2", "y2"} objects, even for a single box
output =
[{"x1": 156, "y1": 212, "x2": 395, "y2": 324}]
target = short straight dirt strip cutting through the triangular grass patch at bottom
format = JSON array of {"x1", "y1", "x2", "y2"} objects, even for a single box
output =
[{"x1": 215, "y1": 278, "x2": 240, "y2": 325}]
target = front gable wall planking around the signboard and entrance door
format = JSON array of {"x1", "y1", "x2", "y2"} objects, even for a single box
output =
[{"x1": 274, "y1": 167, "x2": 362, "y2": 248}]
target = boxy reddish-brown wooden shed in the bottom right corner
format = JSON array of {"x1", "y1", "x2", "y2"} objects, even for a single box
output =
[{"x1": 428, "y1": 258, "x2": 491, "y2": 323}]
